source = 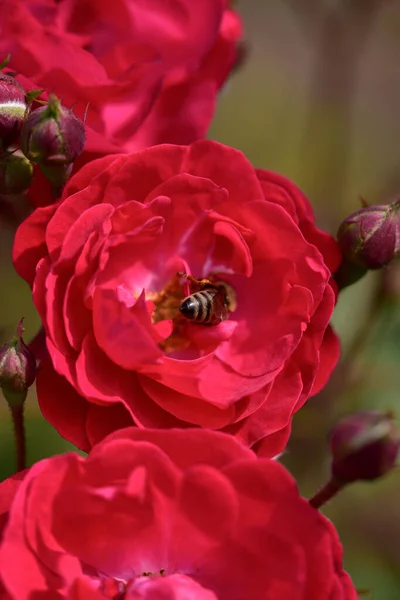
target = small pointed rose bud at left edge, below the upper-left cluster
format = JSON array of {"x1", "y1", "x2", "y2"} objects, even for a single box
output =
[{"x1": 0, "y1": 319, "x2": 36, "y2": 407}]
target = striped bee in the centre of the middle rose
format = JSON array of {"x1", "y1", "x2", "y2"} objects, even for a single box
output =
[{"x1": 177, "y1": 273, "x2": 236, "y2": 325}]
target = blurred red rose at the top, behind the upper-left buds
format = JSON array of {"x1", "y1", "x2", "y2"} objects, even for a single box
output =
[{"x1": 0, "y1": 0, "x2": 242, "y2": 161}]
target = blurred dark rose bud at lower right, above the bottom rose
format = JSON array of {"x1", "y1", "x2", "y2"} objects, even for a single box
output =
[{"x1": 331, "y1": 410, "x2": 400, "y2": 484}]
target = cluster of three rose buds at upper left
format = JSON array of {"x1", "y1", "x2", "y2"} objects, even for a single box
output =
[{"x1": 0, "y1": 64, "x2": 85, "y2": 196}]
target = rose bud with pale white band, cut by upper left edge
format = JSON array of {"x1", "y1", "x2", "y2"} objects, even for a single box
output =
[{"x1": 0, "y1": 73, "x2": 26, "y2": 151}]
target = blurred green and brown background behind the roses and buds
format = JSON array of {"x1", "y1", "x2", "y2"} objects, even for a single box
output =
[{"x1": 0, "y1": 0, "x2": 400, "y2": 600}]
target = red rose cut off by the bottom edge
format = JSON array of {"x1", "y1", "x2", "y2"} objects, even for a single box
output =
[{"x1": 0, "y1": 428, "x2": 357, "y2": 600}]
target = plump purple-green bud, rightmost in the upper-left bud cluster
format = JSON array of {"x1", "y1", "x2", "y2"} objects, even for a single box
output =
[{"x1": 21, "y1": 96, "x2": 86, "y2": 167}]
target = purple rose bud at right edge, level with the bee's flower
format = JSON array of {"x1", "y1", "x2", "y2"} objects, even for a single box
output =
[{"x1": 337, "y1": 200, "x2": 400, "y2": 269}]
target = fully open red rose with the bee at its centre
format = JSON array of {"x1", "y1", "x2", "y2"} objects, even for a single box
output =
[{"x1": 13, "y1": 141, "x2": 340, "y2": 456}]
